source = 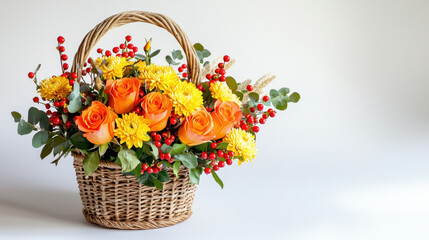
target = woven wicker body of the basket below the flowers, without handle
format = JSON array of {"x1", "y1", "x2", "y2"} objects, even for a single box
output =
[{"x1": 72, "y1": 153, "x2": 196, "y2": 229}]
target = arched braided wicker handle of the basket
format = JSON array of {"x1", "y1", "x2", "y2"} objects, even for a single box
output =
[{"x1": 71, "y1": 11, "x2": 201, "y2": 84}]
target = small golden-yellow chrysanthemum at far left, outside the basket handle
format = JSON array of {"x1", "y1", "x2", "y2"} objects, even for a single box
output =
[{"x1": 38, "y1": 76, "x2": 72, "y2": 100}]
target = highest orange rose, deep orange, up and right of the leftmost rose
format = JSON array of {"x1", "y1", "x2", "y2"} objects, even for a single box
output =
[{"x1": 104, "y1": 78, "x2": 140, "y2": 114}]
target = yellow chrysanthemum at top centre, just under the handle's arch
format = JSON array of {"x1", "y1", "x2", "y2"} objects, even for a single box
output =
[{"x1": 135, "y1": 62, "x2": 180, "y2": 91}]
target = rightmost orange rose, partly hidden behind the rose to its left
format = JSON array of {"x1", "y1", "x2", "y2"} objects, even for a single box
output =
[{"x1": 210, "y1": 100, "x2": 243, "y2": 139}]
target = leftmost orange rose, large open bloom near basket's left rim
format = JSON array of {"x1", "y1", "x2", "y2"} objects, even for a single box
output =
[{"x1": 76, "y1": 101, "x2": 118, "y2": 145}]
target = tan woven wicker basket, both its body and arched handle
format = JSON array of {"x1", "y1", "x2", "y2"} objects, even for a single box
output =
[{"x1": 72, "y1": 11, "x2": 201, "y2": 229}]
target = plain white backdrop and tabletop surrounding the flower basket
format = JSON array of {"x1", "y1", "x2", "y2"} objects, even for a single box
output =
[{"x1": 0, "y1": 0, "x2": 429, "y2": 240}]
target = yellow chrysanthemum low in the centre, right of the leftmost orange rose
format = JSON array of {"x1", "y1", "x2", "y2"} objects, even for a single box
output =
[{"x1": 114, "y1": 113, "x2": 150, "y2": 148}]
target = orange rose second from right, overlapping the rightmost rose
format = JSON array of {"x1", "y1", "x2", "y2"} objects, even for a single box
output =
[{"x1": 179, "y1": 107, "x2": 214, "y2": 146}]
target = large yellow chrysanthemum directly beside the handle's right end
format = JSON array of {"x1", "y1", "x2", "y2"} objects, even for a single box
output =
[{"x1": 166, "y1": 81, "x2": 203, "y2": 117}]
